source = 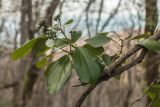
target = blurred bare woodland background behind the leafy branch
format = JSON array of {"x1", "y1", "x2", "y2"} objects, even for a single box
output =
[{"x1": 0, "y1": 0, "x2": 160, "y2": 107}]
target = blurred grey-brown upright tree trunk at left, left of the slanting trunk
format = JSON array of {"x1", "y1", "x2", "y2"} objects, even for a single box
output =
[{"x1": 13, "y1": 0, "x2": 32, "y2": 107}]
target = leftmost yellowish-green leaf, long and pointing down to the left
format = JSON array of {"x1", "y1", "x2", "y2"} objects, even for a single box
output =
[{"x1": 11, "y1": 38, "x2": 38, "y2": 60}]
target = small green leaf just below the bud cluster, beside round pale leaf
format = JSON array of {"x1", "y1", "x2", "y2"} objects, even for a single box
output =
[{"x1": 54, "y1": 38, "x2": 69, "y2": 47}]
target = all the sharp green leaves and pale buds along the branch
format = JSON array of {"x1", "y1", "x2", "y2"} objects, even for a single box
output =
[{"x1": 12, "y1": 16, "x2": 160, "y2": 94}]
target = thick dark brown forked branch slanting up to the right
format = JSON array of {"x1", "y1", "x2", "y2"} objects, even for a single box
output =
[{"x1": 75, "y1": 31, "x2": 160, "y2": 107}]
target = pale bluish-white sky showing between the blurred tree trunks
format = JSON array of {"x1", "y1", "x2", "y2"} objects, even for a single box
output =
[{"x1": 0, "y1": 0, "x2": 160, "y2": 46}]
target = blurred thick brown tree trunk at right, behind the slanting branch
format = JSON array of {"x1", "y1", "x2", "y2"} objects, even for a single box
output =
[{"x1": 145, "y1": 0, "x2": 159, "y2": 103}]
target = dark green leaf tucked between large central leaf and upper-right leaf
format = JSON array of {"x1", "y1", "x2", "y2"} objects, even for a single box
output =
[{"x1": 83, "y1": 44, "x2": 104, "y2": 55}]
